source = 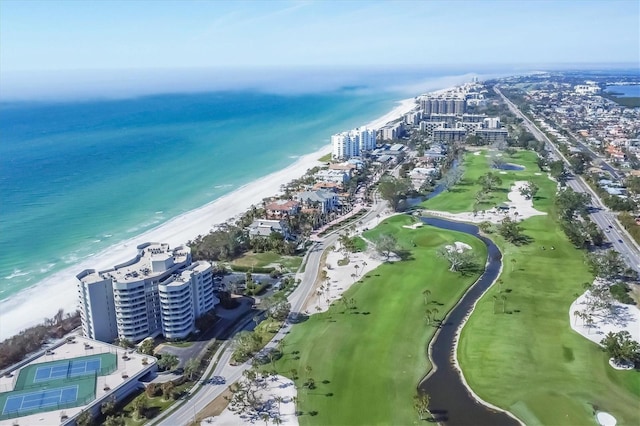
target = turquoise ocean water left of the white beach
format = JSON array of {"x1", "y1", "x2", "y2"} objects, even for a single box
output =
[{"x1": 0, "y1": 91, "x2": 400, "y2": 299}]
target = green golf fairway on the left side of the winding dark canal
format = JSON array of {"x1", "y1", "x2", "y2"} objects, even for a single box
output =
[{"x1": 269, "y1": 215, "x2": 486, "y2": 425}]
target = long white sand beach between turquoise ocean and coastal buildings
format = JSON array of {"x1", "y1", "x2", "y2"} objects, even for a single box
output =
[{"x1": 0, "y1": 95, "x2": 420, "y2": 341}]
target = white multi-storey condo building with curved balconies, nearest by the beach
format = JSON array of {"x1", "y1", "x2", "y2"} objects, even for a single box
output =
[{"x1": 76, "y1": 243, "x2": 219, "y2": 342}]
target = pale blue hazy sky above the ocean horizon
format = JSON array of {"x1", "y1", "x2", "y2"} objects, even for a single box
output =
[{"x1": 0, "y1": 0, "x2": 640, "y2": 98}]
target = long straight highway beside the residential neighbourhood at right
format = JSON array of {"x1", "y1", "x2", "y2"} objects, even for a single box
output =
[{"x1": 494, "y1": 87, "x2": 640, "y2": 272}]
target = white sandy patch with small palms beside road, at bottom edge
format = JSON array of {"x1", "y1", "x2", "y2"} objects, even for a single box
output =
[{"x1": 200, "y1": 376, "x2": 298, "y2": 426}]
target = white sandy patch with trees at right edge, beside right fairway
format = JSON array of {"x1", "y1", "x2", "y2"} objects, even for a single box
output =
[{"x1": 569, "y1": 280, "x2": 640, "y2": 344}]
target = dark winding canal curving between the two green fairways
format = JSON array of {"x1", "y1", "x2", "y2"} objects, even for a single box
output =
[{"x1": 418, "y1": 217, "x2": 519, "y2": 426}]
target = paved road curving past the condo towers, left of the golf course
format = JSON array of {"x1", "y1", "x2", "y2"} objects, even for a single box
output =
[{"x1": 158, "y1": 193, "x2": 387, "y2": 426}]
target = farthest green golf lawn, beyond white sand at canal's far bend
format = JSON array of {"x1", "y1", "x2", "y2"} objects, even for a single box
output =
[{"x1": 420, "y1": 151, "x2": 540, "y2": 213}]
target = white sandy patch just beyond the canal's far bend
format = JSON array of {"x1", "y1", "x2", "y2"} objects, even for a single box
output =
[{"x1": 423, "y1": 180, "x2": 547, "y2": 223}]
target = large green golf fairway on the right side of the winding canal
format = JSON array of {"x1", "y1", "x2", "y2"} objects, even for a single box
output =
[{"x1": 422, "y1": 152, "x2": 640, "y2": 425}]
